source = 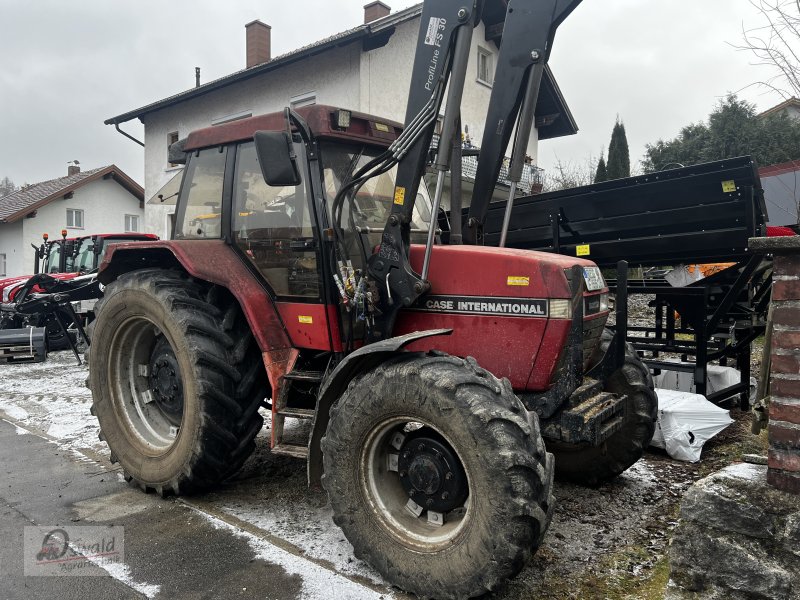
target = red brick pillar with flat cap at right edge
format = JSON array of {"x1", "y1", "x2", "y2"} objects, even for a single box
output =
[{"x1": 750, "y1": 236, "x2": 800, "y2": 494}]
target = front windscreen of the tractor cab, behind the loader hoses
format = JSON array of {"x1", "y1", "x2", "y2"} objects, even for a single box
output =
[{"x1": 321, "y1": 142, "x2": 431, "y2": 264}]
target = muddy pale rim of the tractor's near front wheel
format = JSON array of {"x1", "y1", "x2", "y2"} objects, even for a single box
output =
[{"x1": 359, "y1": 417, "x2": 472, "y2": 552}]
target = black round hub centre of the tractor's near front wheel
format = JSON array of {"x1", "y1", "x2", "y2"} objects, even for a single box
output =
[{"x1": 397, "y1": 429, "x2": 469, "y2": 513}]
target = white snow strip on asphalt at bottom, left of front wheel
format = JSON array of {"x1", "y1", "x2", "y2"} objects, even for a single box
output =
[{"x1": 194, "y1": 509, "x2": 394, "y2": 600}]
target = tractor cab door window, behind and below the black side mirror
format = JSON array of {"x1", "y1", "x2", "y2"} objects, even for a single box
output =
[{"x1": 233, "y1": 142, "x2": 320, "y2": 299}]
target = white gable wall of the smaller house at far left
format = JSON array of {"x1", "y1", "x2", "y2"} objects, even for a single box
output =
[{"x1": 21, "y1": 179, "x2": 144, "y2": 273}]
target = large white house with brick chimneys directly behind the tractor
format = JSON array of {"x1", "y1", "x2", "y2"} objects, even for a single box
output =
[{"x1": 106, "y1": 1, "x2": 577, "y2": 236}]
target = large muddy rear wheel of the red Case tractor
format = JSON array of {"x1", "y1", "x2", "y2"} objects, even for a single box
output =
[{"x1": 89, "y1": 269, "x2": 267, "y2": 495}]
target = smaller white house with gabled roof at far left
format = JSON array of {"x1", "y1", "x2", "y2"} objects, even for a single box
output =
[{"x1": 0, "y1": 165, "x2": 144, "y2": 277}]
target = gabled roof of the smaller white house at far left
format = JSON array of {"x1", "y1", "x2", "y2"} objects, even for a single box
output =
[{"x1": 0, "y1": 165, "x2": 144, "y2": 223}]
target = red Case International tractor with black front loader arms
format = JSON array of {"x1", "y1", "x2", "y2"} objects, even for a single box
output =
[{"x1": 89, "y1": 0, "x2": 656, "y2": 598}]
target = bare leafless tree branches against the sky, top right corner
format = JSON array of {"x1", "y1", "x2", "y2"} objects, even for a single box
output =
[{"x1": 732, "y1": 0, "x2": 800, "y2": 99}]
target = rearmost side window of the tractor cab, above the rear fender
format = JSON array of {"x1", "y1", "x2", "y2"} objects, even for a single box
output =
[{"x1": 176, "y1": 148, "x2": 227, "y2": 239}]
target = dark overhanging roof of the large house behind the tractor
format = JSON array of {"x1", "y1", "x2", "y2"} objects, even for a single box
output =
[{"x1": 105, "y1": 4, "x2": 578, "y2": 139}]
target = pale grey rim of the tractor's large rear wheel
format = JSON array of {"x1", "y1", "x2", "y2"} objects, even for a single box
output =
[{"x1": 108, "y1": 317, "x2": 184, "y2": 456}]
